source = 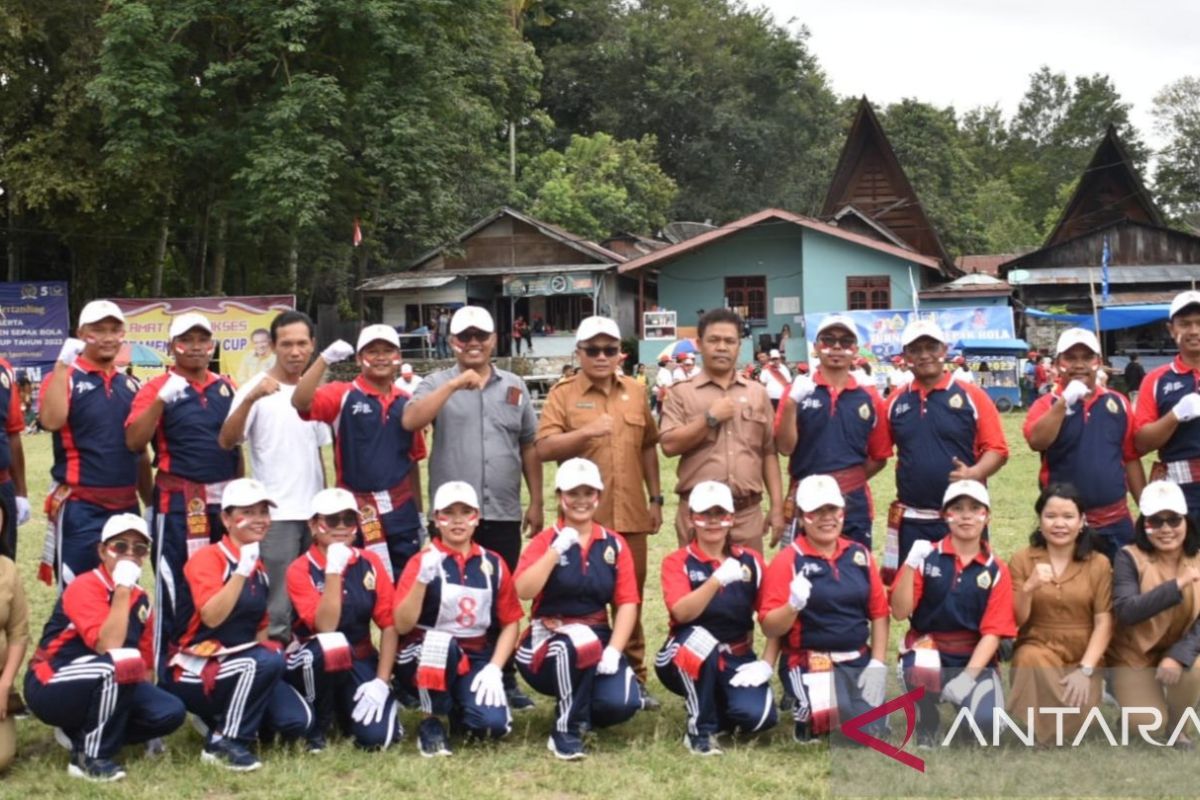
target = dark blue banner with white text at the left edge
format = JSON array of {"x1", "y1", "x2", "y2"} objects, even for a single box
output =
[{"x1": 0, "y1": 281, "x2": 71, "y2": 383}]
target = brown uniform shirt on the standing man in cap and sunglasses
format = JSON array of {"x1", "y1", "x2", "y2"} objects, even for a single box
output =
[{"x1": 536, "y1": 372, "x2": 659, "y2": 534}]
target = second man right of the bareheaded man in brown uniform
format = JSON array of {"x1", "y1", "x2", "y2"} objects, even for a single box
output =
[{"x1": 882, "y1": 319, "x2": 1008, "y2": 583}]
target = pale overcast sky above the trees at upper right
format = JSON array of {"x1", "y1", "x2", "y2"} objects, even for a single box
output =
[{"x1": 763, "y1": 0, "x2": 1200, "y2": 146}]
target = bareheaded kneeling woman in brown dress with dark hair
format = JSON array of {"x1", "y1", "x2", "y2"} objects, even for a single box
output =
[{"x1": 1009, "y1": 483, "x2": 1112, "y2": 745}]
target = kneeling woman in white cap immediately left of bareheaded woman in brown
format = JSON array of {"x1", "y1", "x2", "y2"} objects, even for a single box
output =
[{"x1": 892, "y1": 481, "x2": 1016, "y2": 747}]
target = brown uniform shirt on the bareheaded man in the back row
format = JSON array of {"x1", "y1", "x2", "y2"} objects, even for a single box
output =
[{"x1": 662, "y1": 372, "x2": 776, "y2": 498}]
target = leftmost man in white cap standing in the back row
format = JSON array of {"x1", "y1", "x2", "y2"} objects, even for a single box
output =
[{"x1": 37, "y1": 300, "x2": 150, "y2": 588}]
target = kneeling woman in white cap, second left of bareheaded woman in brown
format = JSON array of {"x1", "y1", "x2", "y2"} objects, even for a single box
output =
[{"x1": 758, "y1": 475, "x2": 888, "y2": 744}]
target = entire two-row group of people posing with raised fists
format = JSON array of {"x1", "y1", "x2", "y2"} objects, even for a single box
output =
[{"x1": 0, "y1": 291, "x2": 1200, "y2": 780}]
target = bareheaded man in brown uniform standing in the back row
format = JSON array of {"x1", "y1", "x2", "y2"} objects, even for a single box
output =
[{"x1": 661, "y1": 308, "x2": 784, "y2": 553}]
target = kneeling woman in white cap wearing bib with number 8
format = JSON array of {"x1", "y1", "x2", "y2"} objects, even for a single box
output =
[{"x1": 394, "y1": 481, "x2": 524, "y2": 758}]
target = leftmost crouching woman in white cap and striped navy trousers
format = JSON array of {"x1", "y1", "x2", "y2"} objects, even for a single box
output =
[{"x1": 24, "y1": 513, "x2": 187, "y2": 782}]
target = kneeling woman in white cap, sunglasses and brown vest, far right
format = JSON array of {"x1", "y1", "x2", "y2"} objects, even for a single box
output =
[{"x1": 1109, "y1": 481, "x2": 1200, "y2": 748}]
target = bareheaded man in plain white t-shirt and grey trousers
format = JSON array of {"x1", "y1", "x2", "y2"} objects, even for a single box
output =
[{"x1": 218, "y1": 311, "x2": 332, "y2": 642}]
